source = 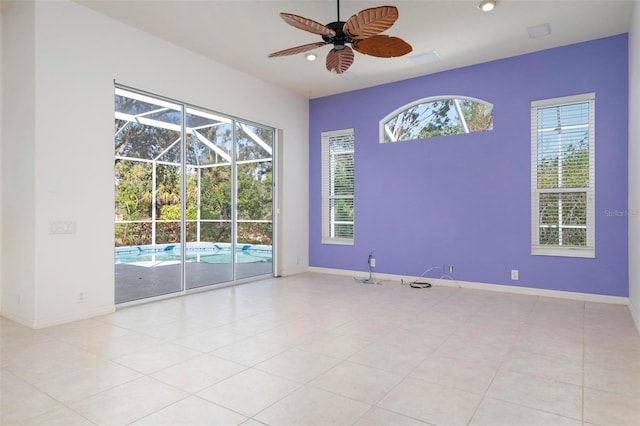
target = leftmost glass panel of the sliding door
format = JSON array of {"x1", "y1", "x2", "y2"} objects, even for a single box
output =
[{"x1": 114, "y1": 89, "x2": 182, "y2": 303}]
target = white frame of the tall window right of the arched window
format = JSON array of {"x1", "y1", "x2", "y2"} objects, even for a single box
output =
[{"x1": 531, "y1": 93, "x2": 596, "y2": 258}]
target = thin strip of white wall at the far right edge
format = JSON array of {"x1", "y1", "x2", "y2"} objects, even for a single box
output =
[{"x1": 628, "y1": 0, "x2": 640, "y2": 331}]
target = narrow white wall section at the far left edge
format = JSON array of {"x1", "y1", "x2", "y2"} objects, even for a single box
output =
[{"x1": 2, "y1": 3, "x2": 36, "y2": 322}]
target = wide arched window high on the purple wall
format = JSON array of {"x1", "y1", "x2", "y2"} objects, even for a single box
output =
[{"x1": 380, "y1": 96, "x2": 493, "y2": 143}]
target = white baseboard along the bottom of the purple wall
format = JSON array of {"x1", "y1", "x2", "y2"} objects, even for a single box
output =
[{"x1": 309, "y1": 266, "x2": 628, "y2": 306}]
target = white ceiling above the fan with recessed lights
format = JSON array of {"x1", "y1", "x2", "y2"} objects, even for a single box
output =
[{"x1": 76, "y1": 0, "x2": 633, "y2": 98}]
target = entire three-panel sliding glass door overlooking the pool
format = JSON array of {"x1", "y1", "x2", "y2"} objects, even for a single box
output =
[{"x1": 114, "y1": 88, "x2": 275, "y2": 303}]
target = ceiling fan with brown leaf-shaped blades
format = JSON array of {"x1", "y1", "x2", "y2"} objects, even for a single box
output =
[{"x1": 269, "y1": 0, "x2": 413, "y2": 74}]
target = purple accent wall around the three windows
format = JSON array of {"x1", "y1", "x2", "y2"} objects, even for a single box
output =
[{"x1": 309, "y1": 34, "x2": 629, "y2": 296}]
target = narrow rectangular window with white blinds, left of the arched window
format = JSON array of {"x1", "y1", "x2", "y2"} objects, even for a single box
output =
[{"x1": 322, "y1": 129, "x2": 354, "y2": 244}]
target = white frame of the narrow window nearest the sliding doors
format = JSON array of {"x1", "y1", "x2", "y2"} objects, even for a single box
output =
[{"x1": 321, "y1": 129, "x2": 355, "y2": 245}]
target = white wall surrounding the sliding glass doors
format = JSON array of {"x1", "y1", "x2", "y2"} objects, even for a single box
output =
[{"x1": 2, "y1": 1, "x2": 308, "y2": 327}]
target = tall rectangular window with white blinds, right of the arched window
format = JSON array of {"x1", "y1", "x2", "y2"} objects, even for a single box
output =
[{"x1": 531, "y1": 93, "x2": 595, "y2": 257}]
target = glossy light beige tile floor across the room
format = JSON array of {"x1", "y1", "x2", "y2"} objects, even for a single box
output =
[{"x1": 0, "y1": 273, "x2": 640, "y2": 426}]
